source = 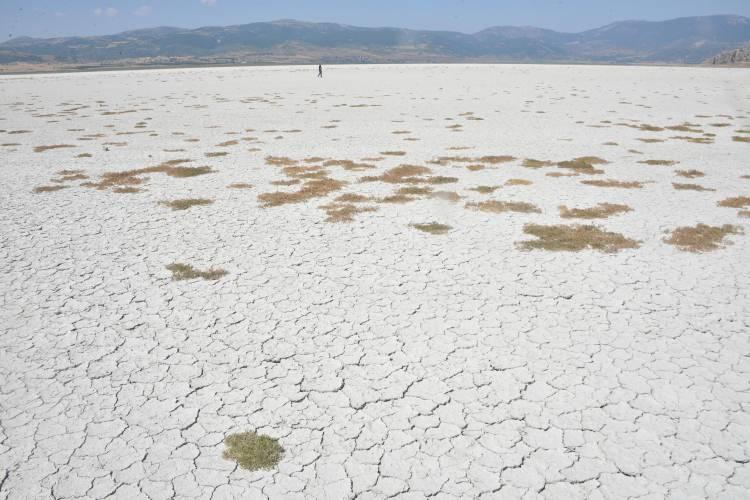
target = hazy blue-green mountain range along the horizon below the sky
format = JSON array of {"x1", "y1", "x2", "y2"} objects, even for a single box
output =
[{"x1": 0, "y1": 15, "x2": 750, "y2": 69}]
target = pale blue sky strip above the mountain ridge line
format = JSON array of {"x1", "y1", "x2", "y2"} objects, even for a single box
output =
[{"x1": 0, "y1": 0, "x2": 750, "y2": 40}]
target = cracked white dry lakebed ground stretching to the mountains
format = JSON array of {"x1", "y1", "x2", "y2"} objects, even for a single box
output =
[{"x1": 0, "y1": 66, "x2": 750, "y2": 499}]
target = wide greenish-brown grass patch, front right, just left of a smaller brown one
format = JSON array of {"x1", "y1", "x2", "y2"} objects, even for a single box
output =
[{"x1": 519, "y1": 224, "x2": 639, "y2": 253}]
